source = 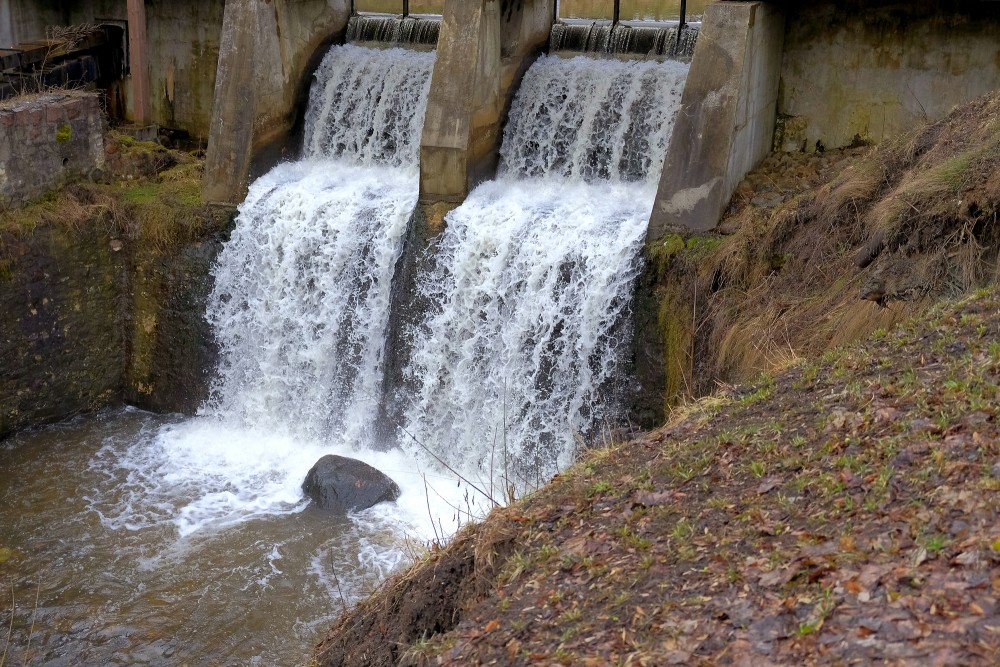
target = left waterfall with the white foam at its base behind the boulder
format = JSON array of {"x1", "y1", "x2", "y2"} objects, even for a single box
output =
[{"x1": 105, "y1": 46, "x2": 434, "y2": 535}]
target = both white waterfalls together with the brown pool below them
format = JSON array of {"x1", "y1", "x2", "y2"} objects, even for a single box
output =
[{"x1": 0, "y1": 40, "x2": 687, "y2": 665}]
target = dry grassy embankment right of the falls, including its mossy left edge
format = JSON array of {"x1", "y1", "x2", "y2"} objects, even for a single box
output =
[{"x1": 644, "y1": 94, "x2": 1000, "y2": 408}]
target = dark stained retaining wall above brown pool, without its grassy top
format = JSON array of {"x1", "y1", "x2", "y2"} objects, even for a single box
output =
[{"x1": 0, "y1": 190, "x2": 229, "y2": 439}]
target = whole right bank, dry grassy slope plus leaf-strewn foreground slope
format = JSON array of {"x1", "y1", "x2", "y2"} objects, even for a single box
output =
[{"x1": 317, "y1": 96, "x2": 1000, "y2": 665}]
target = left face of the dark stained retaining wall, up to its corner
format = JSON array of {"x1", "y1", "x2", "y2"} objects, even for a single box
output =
[{"x1": 0, "y1": 226, "x2": 126, "y2": 438}]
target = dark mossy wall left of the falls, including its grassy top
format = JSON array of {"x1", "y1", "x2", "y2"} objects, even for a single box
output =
[{"x1": 0, "y1": 134, "x2": 232, "y2": 438}]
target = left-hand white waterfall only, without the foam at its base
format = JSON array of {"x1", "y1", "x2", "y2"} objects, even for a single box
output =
[{"x1": 205, "y1": 46, "x2": 433, "y2": 444}]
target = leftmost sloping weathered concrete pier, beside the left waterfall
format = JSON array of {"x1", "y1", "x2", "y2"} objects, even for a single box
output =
[{"x1": 204, "y1": 0, "x2": 350, "y2": 203}]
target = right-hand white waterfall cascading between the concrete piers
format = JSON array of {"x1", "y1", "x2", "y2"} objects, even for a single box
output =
[{"x1": 404, "y1": 57, "x2": 688, "y2": 489}]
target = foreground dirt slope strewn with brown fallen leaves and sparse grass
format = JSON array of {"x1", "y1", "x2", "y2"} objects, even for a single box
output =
[{"x1": 318, "y1": 290, "x2": 1000, "y2": 665}]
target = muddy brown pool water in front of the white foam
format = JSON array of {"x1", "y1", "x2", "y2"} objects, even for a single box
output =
[{"x1": 0, "y1": 410, "x2": 414, "y2": 666}]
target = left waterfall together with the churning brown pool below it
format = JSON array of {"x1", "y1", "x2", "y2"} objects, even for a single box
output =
[{"x1": 0, "y1": 46, "x2": 442, "y2": 665}]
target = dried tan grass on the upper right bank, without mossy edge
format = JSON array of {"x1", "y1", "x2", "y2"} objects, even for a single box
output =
[{"x1": 702, "y1": 87, "x2": 1000, "y2": 381}]
